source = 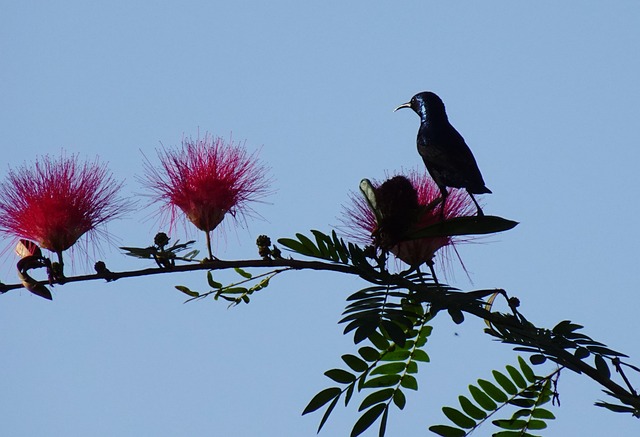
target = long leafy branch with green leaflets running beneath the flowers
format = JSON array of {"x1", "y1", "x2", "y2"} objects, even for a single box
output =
[{"x1": 0, "y1": 223, "x2": 640, "y2": 437}]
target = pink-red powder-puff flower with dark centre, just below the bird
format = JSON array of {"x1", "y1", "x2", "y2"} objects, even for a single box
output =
[{"x1": 341, "y1": 171, "x2": 474, "y2": 267}]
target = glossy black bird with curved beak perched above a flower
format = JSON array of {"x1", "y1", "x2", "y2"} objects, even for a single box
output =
[{"x1": 395, "y1": 91, "x2": 491, "y2": 215}]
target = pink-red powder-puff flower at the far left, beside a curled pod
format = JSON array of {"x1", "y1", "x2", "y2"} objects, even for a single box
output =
[{"x1": 0, "y1": 154, "x2": 128, "y2": 257}]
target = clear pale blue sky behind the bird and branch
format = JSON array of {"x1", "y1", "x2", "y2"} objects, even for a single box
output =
[{"x1": 0, "y1": 0, "x2": 640, "y2": 436}]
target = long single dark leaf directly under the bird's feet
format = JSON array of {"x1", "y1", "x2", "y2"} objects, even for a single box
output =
[{"x1": 407, "y1": 215, "x2": 518, "y2": 240}]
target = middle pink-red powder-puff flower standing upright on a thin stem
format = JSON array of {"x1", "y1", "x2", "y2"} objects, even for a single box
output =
[{"x1": 145, "y1": 134, "x2": 269, "y2": 255}]
